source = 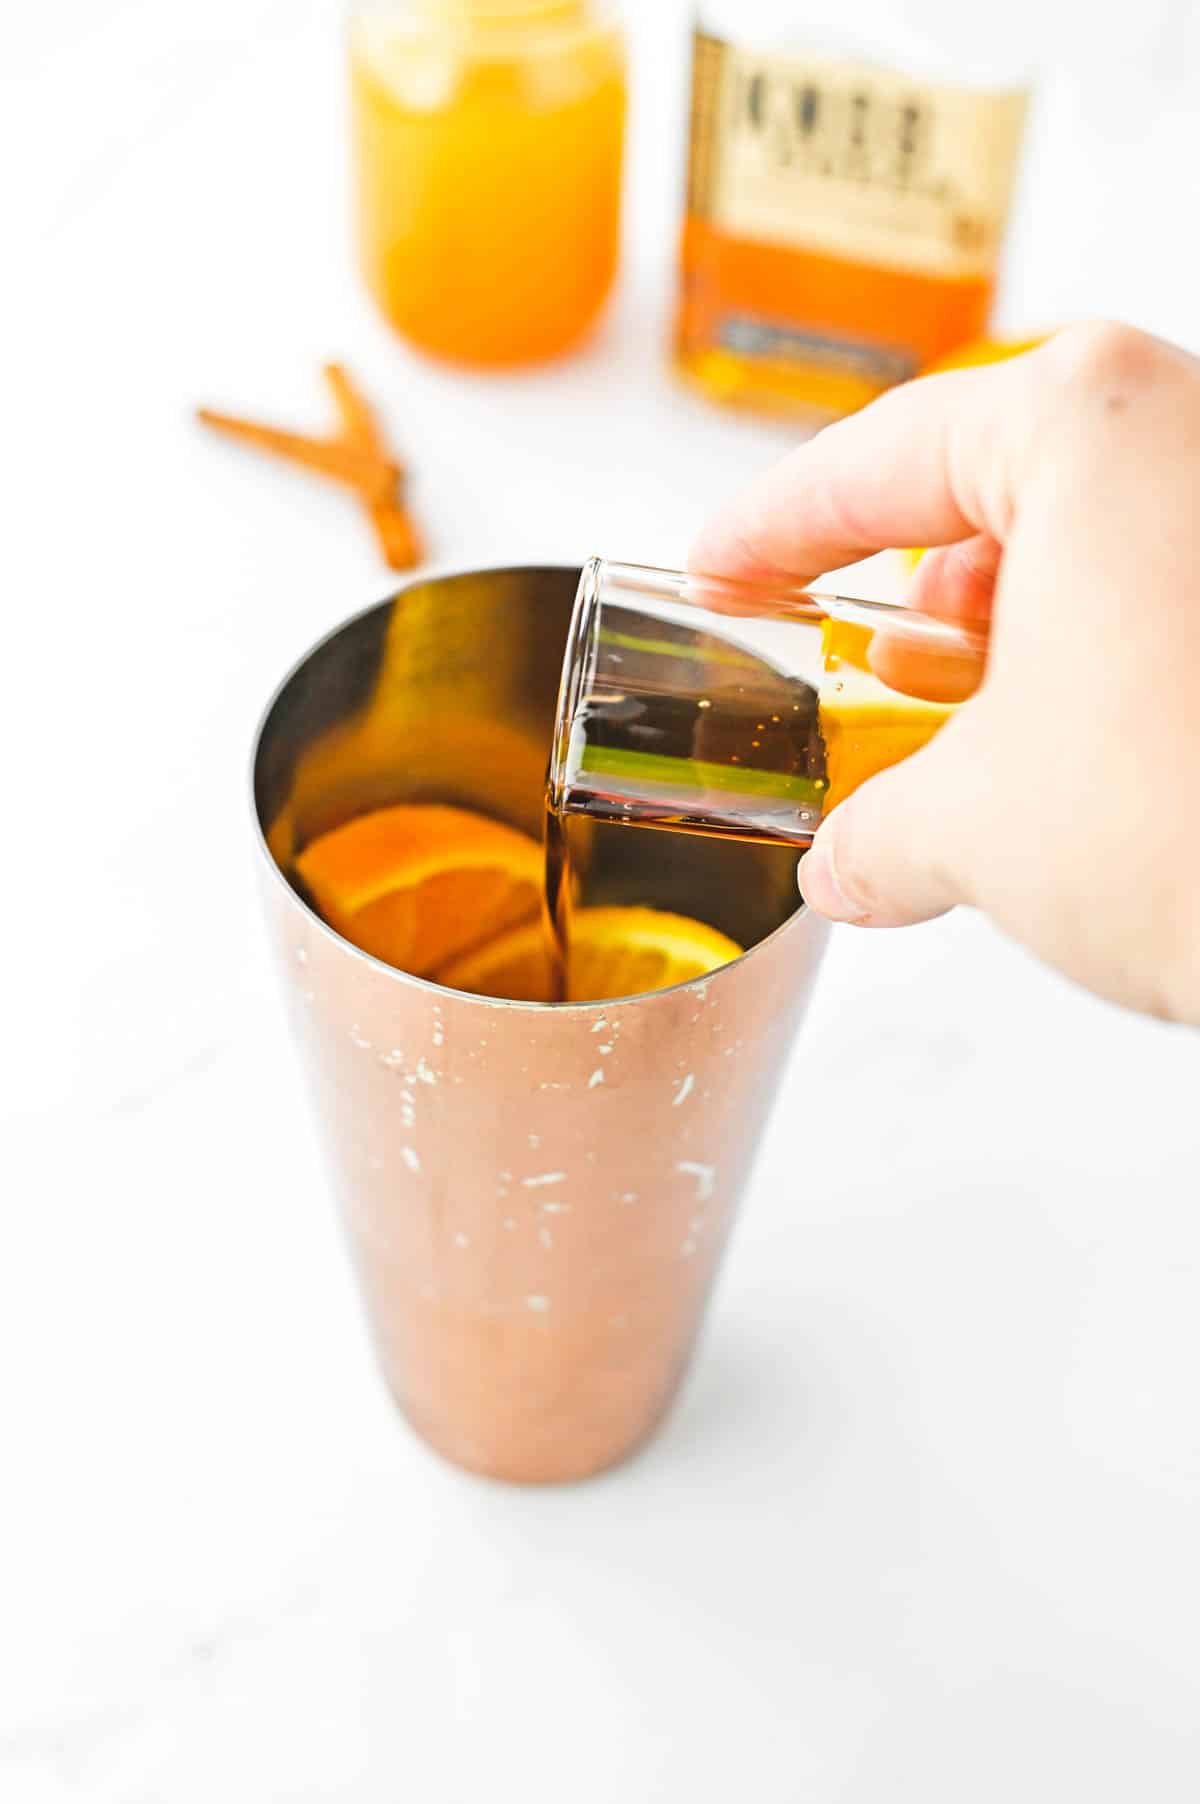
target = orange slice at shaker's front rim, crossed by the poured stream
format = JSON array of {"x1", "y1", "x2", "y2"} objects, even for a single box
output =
[{"x1": 437, "y1": 907, "x2": 742, "y2": 1003}]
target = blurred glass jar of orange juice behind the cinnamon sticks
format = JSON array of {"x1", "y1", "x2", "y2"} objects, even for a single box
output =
[{"x1": 350, "y1": 0, "x2": 626, "y2": 366}]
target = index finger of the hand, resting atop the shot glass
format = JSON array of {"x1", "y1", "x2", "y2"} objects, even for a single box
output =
[{"x1": 688, "y1": 346, "x2": 1048, "y2": 583}]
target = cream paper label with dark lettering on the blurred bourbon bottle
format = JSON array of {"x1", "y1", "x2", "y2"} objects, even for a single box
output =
[{"x1": 688, "y1": 32, "x2": 1027, "y2": 278}]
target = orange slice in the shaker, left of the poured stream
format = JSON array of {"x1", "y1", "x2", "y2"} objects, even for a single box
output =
[{"x1": 296, "y1": 803, "x2": 543, "y2": 978}]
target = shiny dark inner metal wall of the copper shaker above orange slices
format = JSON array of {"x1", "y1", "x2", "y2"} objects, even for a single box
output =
[{"x1": 254, "y1": 566, "x2": 799, "y2": 947}]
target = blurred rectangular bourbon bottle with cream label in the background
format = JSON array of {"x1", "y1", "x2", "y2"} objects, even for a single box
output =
[{"x1": 675, "y1": 0, "x2": 1027, "y2": 420}]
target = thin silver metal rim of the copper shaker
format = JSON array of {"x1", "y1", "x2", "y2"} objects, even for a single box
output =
[{"x1": 249, "y1": 559, "x2": 808, "y2": 1016}]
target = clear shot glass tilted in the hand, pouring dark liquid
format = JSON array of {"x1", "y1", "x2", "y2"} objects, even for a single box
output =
[{"x1": 549, "y1": 557, "x2": 987, "y2": 848}]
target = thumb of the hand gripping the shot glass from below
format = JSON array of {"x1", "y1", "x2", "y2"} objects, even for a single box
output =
[{"x1": 798, "y1": 716, "x2": 987, "y2": 927}]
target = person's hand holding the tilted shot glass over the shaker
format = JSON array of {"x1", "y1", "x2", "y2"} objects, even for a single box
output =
[{"x1": 689, "y1": 325, "x2": 1200, "y2": 1023}]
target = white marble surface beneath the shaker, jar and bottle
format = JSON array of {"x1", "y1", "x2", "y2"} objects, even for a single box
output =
[{"x1": 0, "y1": 0, "x2": 1200, "y2": 1804}]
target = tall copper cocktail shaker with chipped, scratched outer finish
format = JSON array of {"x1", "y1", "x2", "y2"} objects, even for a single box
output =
[{"x1": 253, "y1": 568, "x2": 825, "y2": 1481}]
